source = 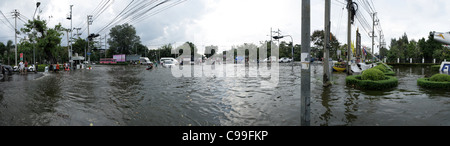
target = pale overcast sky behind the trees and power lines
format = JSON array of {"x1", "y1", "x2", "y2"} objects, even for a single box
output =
[{"x1": 0, "y1": 0, "x2": 450, "y2": 52}]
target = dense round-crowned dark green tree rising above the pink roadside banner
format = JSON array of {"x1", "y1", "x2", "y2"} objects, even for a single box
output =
[{"x1": 108, "y1": 23, "x2": 141, "y2": 54}]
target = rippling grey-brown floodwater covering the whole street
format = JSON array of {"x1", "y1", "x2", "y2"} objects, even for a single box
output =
[{"x1": 0, "y1": 63, "x2": 450, "y2": 126}]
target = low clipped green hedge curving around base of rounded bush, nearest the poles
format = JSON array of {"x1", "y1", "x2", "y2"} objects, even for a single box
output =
[{"x1": 345, "y1": 75, "x2": 398, "y2": 90}]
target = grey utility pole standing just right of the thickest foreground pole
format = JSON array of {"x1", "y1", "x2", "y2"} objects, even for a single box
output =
[{"x1": 323, "y1": 0, "x2": 331, "y2": 87}]
